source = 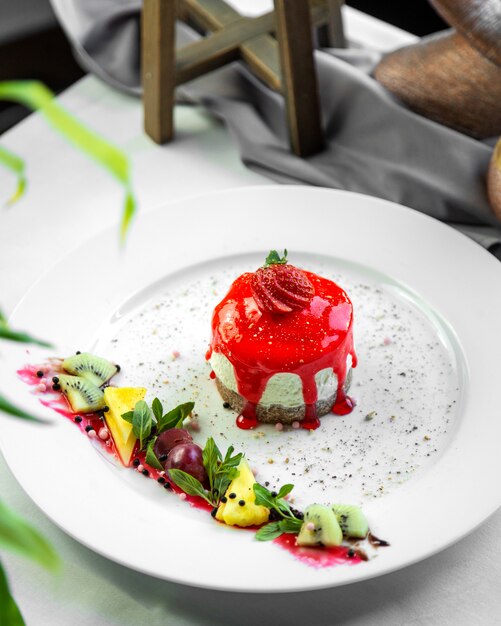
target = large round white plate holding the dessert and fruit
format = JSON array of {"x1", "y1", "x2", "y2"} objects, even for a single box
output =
[{"x1": 0, "y1": 187, "x2": 501, "y2": 592}]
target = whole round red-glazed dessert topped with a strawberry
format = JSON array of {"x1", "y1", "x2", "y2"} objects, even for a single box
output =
[{"x1": 207, "y1": 250, "x2": 357, "y2": 429}]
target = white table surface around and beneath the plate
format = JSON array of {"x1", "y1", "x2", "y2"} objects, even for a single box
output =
[{"x1": 0, "y1": 6, "x2": 501, "y2": 626}]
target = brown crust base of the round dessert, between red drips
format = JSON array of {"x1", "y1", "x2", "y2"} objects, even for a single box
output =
[{"x1": 216, "y1": 369, "x2": 351, "y2": 424}]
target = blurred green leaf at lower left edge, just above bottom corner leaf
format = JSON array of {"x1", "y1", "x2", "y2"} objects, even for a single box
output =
[{"x1": 0, "y1": 501, "x2": 59, "y2": 570}]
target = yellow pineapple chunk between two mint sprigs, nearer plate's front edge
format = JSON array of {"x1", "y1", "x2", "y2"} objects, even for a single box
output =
[{"x1": 216, "y1": 458, "x2": 270, "y2": 527}]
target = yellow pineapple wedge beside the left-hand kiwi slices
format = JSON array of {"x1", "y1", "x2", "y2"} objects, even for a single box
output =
[{"x1": 104, "y1": 387, "x2": 146, "y2": 465}]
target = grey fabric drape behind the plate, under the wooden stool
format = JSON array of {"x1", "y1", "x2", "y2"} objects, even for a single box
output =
[{"x1": 52, "y1": 0, "x2": 501, "y2": 258}]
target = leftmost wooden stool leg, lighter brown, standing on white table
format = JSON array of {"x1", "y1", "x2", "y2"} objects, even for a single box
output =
[{"x1": 141, "y1": 0, "x2": 176, "y2": 143}]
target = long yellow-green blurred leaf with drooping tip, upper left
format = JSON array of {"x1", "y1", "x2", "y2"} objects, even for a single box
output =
[{"x1": 0, "y1": 80, "x2": 136, "y2": 242}]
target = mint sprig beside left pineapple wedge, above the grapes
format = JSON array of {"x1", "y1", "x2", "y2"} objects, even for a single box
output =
[{"x1": 122, "y1": 398, "x2": 195, "y2": 460}]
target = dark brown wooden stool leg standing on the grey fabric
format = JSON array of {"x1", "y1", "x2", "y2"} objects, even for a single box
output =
[{"x1": 275, "y1": 0, "x2": 324, "y2": 156}]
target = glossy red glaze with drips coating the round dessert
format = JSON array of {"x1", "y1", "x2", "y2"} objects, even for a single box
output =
[{"x1": 209, "y1": 272, "x2": 357, "y2": 429}]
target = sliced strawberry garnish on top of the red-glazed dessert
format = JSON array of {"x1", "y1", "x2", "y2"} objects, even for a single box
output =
[{"x1": 251, "y1": 250, "x2": 315, "y2": 314}]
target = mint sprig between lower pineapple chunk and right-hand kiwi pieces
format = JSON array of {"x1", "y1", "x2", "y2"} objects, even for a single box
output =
[{"x1": 253, "y1": 483, "x2": 303, "y2": 541}]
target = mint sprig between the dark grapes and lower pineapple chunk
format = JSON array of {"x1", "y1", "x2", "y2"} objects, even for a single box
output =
[{"x1": 169, "y1": 437, "x2": 243, "y2": 507}]
